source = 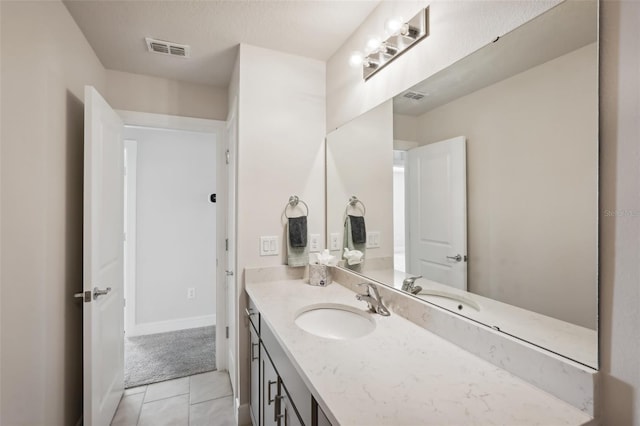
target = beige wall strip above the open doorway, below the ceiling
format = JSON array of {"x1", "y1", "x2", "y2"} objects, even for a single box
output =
[{"x1": 104, "y1": 70, "x2": 228, "y2": 120}]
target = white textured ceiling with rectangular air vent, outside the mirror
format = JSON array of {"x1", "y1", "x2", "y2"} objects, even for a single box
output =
[{"x1": 64, "y1": 0, "x2": 380, "y2": 87}]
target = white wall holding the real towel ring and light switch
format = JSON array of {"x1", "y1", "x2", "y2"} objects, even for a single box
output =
[{"x1": 234, "y1": 44, "x2": 325, "y2": 410}]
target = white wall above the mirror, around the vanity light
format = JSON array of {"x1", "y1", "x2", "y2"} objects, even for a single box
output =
[{"x1": 327, "y1": 0, "x2": 560, "y2": 131}]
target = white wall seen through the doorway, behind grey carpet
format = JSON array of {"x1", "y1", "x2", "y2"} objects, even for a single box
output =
[{"x1": 124, "y1": 127, "x2": 219, "y2": 335}]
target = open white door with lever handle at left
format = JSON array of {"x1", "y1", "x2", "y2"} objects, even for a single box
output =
[{"x1": 83, "y1": 86, "x2": 124, "y2": 426}]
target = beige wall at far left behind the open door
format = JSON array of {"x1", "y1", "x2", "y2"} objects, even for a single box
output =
[{"x1": 0, "y1": 1, "x2": 106, "y2": 426}]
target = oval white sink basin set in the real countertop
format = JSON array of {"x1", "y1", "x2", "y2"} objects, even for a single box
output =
[{"x1": 295, "y1": 303, "x2": 376, "y2": 340}]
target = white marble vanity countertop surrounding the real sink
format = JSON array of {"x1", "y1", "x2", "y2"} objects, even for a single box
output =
[{"x1": 246, "y1": 280, "x2": 592, "y2": 426}]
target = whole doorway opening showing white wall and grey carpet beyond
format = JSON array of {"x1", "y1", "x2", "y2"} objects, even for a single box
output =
[{"x1": 123, "y1": 114, "x2": 226, "y2": 388}]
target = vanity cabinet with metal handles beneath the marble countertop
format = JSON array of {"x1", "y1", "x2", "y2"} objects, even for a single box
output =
[{"x1": 247, "y1": 299, "x2": 330, "y2": 426}]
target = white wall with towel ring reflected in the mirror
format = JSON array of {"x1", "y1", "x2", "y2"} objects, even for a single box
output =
[{"x1": 326, "y1": 100, "x2": 393, "y2": 264}]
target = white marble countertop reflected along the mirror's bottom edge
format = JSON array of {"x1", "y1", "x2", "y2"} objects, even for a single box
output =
[{"x1": 366, "y1": 269, "x2": 598, "y2": 368}]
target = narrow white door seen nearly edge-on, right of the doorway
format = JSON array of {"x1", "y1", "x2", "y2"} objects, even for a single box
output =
[{"x1": 225, "y1": 101, "x2": 238, "y2": 395}]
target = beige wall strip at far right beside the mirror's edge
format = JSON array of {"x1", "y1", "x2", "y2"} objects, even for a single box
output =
[{"x1": 600, "y1": 0, "x2": 640, "y2": 425}]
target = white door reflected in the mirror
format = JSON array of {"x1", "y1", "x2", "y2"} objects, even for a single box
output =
[{"x1": 406, "y1": 136, "x2": 467, "y2": 290}]
